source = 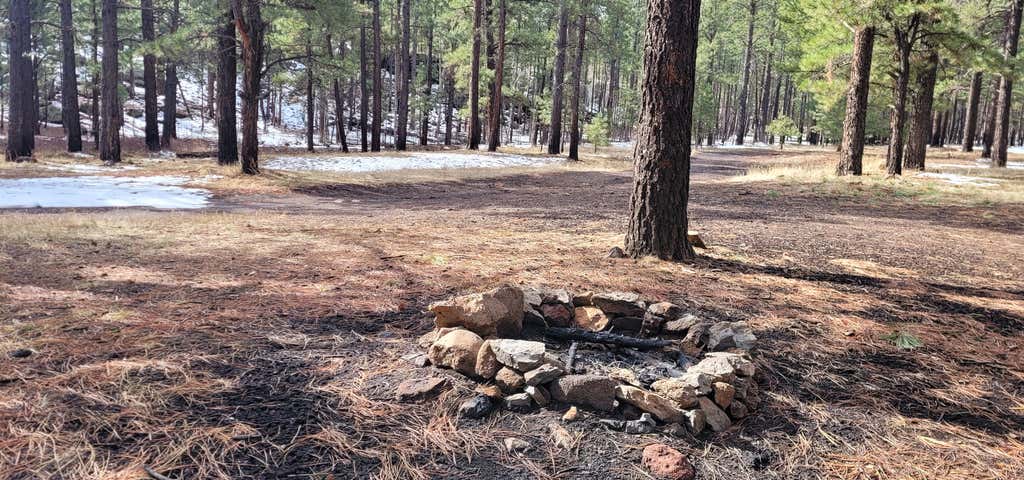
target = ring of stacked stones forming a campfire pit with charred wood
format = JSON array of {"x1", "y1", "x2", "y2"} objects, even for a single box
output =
[{"x1": 402, "y1": 286, "x2": 760, "y2": 434}]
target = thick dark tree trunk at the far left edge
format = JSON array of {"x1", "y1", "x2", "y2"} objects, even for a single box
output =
[{"x1": 4, "y1": 0, "x2": 36, "y2": 162}]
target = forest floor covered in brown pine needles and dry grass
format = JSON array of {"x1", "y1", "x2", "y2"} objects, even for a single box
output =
[{"x1": 0, "y1": 142, "x2": 1024, "y2": 479}]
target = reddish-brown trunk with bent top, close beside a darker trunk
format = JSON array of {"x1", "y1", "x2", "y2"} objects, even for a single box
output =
[{"x1": 231, "y1": 0, "x2": 266, "y2": 175}]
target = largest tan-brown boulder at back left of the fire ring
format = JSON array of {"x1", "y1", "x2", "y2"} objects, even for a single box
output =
[{"x1": 429, "y1": 286, "x2": 523, "y2": 338}]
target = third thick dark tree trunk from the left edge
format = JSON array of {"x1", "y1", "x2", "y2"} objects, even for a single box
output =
[{"x1": 99, "y1": 0, "x2": 123, "y2": 164}]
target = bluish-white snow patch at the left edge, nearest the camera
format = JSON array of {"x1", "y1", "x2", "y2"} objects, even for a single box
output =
[{"x1": 0, "y1": 176, "x2": 210, "y2": 209}]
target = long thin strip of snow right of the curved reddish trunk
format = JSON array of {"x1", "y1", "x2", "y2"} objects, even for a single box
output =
[{"x1": 265, "y1": 151, "x2": 561, "y2": 172}]
